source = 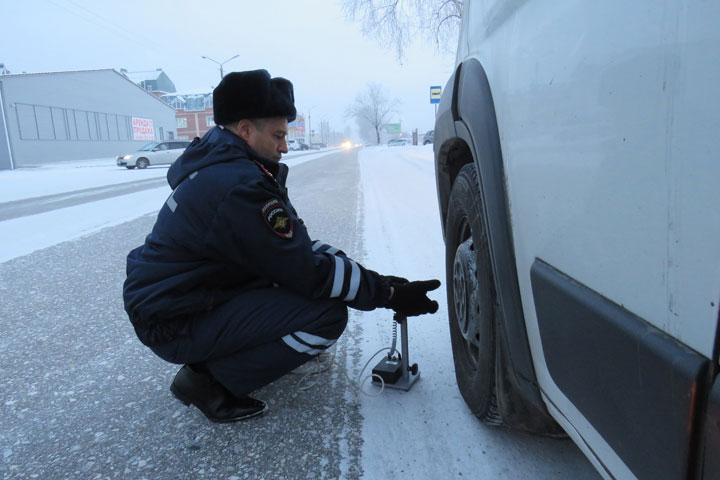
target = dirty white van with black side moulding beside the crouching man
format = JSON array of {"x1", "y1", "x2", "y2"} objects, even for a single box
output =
[{"x1": 434, "y1": 0, "x2": 720, "y2": 479}]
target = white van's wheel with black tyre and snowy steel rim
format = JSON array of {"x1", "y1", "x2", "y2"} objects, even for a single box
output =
[{"x1": 445, "y1": 163, "x2": 503, "y2": 425}]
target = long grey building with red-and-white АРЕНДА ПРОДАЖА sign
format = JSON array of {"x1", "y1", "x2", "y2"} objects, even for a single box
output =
[{"x1": 0, "y1": 69, "x2": 176, "y2": 170}]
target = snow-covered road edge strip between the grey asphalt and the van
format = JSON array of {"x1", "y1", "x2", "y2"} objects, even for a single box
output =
[{"x1": 358, "y1": 145, "x2": 598, "y2": 480}]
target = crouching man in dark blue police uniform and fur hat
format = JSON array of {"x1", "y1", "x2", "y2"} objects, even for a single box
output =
[{"x1": 123, "y1": 70, "x2": 440, "y2": 422}]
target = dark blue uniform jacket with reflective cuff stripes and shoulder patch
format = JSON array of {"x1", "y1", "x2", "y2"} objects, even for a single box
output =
[{"x1": 123, "y1": 127, "x2": 390, "y2": 346}]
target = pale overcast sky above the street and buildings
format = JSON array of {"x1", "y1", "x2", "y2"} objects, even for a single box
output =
[{"x1": 0, "y1": 0, "x2": 454, "y2": 139}]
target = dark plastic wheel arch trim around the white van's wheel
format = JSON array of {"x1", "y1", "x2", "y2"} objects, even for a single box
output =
[{"x1": 436, "y1": 59, "x2": 561, "y2": 434}]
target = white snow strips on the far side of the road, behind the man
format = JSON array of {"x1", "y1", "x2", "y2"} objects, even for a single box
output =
[{"x1": 0, "y1": 150, "x2": 334, "y2": 263}]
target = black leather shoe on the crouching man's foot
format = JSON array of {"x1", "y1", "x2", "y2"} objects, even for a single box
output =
[{"x1": 170, "y1": 365, "x2": 267, "y2": 423}]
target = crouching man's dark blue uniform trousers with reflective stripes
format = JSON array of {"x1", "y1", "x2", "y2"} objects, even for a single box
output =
[{"x1": 152, "y1": 287, "x2": 348, "y2": 396}]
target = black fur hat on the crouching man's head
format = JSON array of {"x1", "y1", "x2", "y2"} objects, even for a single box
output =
[{"x1": 213, "y1": 70, "x2": 296, "y2": 125}]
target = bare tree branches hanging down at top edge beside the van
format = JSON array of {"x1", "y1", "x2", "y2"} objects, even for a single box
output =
[{"x1": 342, "y1": 0, "x2": 464, "y2": 61}]
